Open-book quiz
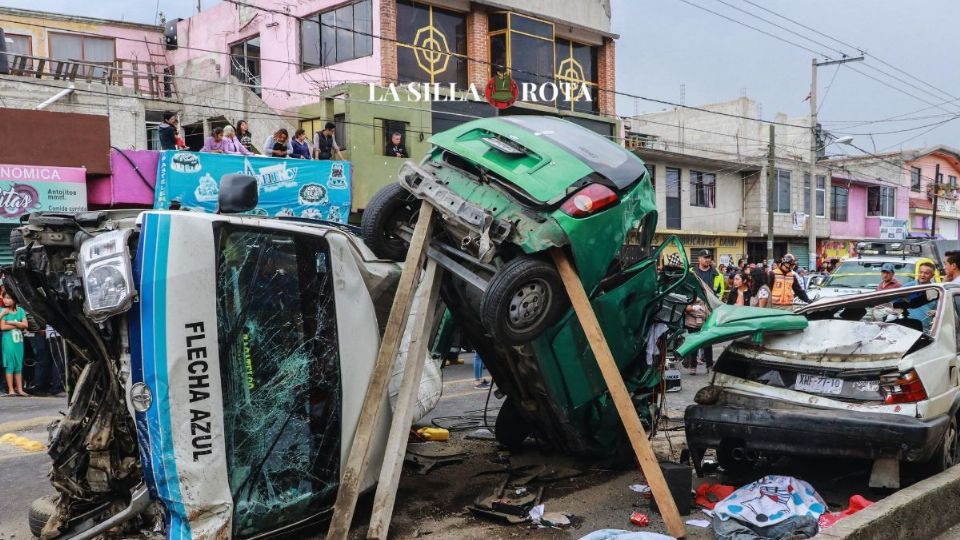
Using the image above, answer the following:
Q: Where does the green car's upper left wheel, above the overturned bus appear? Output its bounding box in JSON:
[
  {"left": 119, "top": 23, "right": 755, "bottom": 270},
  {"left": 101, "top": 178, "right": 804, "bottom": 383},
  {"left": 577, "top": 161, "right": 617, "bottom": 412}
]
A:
[{"left": 360, "top": 183, "right": 421, "bottom": 261}]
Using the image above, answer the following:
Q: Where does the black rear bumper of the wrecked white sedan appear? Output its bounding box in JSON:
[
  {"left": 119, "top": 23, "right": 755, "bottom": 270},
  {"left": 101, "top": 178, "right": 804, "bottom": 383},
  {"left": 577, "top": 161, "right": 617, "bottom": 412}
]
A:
[{"left": 684, "top": 396, "right": 949, "bottom": 461}]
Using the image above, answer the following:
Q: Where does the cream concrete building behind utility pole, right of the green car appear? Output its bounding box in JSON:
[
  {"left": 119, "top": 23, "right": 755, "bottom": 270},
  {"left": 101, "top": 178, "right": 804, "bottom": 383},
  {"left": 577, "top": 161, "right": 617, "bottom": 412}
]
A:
[{"left": 627, "top": 98, "right": 830, "bottom": 266}]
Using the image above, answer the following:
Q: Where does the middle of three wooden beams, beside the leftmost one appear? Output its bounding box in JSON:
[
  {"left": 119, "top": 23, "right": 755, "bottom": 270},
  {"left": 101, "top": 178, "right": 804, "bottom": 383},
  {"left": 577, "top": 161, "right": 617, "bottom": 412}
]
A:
[{"left": 367, "top": 259, "right": 441, "bottom": 540}]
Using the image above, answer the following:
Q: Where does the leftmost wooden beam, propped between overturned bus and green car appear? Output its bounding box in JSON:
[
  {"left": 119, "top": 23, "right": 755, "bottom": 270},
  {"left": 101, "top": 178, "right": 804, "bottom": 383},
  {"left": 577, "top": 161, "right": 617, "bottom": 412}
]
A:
[{"left": 327, "top": 204, "right": 433, "bottom": 540}]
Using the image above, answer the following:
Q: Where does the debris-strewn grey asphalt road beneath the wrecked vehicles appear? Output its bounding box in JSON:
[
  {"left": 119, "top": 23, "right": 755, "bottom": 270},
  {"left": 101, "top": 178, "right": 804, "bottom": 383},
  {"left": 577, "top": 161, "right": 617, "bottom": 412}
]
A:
[{"left": 0, "top": 348, "right": 950, "bottom": 540}]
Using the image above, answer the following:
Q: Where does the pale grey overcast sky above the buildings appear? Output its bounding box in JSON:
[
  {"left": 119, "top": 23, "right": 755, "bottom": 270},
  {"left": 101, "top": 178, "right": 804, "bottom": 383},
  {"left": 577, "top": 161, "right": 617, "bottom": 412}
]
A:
[{"left": 0, "top": 0, "right": 960, "bottom": 154}]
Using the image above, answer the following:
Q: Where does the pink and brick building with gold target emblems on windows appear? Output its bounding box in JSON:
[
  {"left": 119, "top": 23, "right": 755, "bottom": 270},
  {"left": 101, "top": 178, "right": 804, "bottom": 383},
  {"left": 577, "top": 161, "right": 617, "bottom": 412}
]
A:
[{"left": 167, "top": 0, "right": 619, "bottom": 210}]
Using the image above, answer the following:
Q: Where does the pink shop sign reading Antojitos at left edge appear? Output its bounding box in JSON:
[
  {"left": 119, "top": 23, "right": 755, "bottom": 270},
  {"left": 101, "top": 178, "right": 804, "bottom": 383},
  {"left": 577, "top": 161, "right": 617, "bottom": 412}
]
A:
[{"left": 0, "top": 165, "right": 87, "bottom": 223}]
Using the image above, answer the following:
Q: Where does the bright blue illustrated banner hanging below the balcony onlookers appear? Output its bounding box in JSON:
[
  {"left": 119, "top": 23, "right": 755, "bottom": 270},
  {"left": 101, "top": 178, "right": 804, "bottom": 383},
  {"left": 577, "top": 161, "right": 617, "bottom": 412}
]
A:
[{"left": 154, "top": 150, "right": 350, "bottom": 223}]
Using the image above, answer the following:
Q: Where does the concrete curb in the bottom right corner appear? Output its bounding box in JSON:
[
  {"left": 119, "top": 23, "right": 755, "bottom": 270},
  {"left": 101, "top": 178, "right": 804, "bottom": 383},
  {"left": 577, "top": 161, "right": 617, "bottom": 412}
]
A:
[{"left": 814, "top": 467, "right": 960, "bottom": 540}]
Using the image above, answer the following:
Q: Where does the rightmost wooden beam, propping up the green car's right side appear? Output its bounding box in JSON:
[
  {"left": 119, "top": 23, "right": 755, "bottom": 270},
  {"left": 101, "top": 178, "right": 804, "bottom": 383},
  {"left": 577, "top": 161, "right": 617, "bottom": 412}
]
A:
[{"left": 550, "top": 248, "right": 687, "bottom": 538}]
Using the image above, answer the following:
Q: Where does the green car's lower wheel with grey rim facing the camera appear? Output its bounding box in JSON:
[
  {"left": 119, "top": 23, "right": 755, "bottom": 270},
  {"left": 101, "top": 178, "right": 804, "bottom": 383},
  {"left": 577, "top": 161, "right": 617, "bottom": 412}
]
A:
[{"left": 480, "top": 256, "right": 569, "bottom": 345}]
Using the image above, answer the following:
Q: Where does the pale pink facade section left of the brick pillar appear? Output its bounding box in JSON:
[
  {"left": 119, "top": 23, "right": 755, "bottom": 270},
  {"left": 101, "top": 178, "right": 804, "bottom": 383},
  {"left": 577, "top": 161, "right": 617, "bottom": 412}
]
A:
[{"left": 168, "top": 0, "right": 381, "bottom": 110}]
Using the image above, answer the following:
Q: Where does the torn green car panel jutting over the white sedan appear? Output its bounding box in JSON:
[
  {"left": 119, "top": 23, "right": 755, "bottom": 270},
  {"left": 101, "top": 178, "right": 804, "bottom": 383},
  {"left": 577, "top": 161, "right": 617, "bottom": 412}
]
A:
[{"left": 677, "top": 304, "right": 809, "bottom": 356}]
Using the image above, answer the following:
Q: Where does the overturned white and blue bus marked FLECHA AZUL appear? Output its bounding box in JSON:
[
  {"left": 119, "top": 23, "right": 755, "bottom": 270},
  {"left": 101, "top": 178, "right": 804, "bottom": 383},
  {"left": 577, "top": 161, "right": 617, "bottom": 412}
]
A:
[{"left": 8, "top": 205, "right": 408, "bottom": 539}]
